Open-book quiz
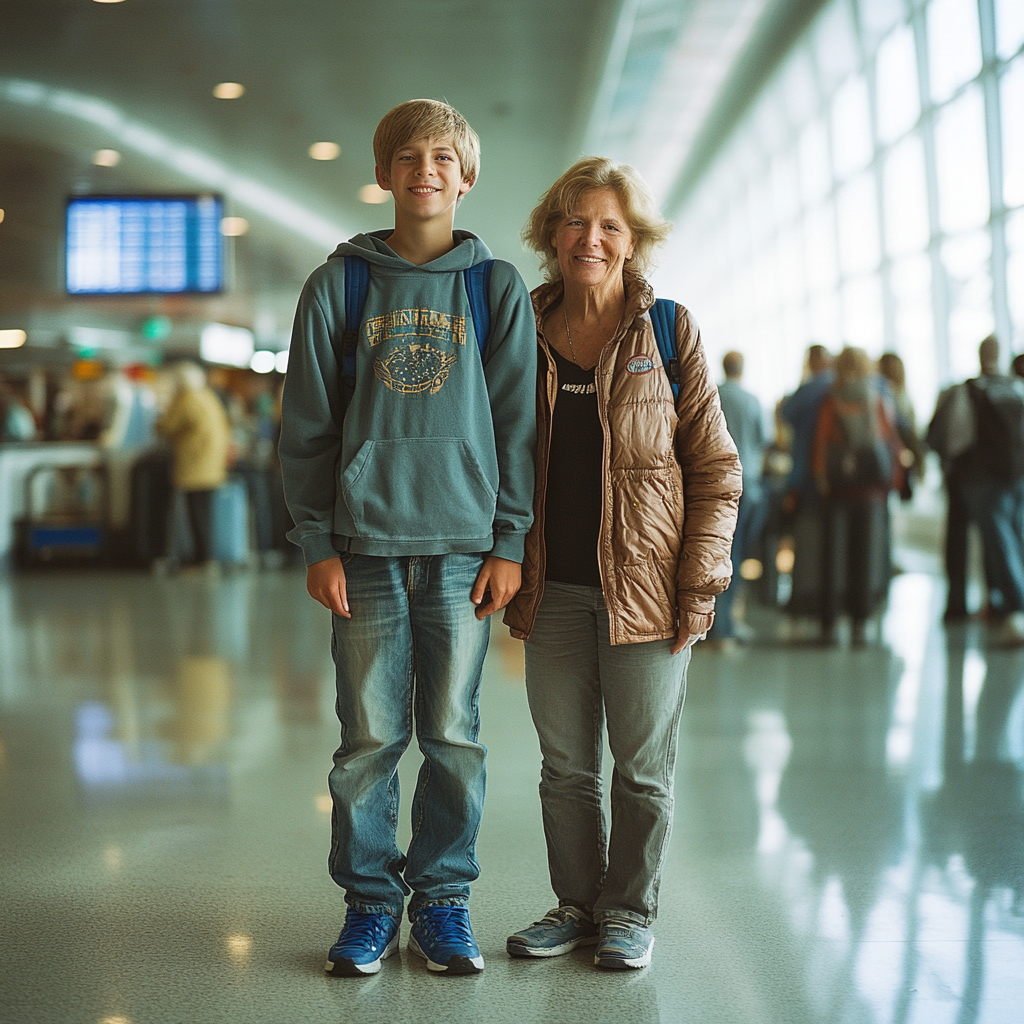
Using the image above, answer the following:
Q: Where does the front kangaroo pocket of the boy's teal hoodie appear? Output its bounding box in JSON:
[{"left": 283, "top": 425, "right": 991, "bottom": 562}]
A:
[{"left": 341, "top": 437, "right": 498, "bottom": 541}]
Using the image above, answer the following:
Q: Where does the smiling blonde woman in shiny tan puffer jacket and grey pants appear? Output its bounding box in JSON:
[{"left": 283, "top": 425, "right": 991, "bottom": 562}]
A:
[{"left": 505, "top": 158, "right": 740, "bottom": 968}]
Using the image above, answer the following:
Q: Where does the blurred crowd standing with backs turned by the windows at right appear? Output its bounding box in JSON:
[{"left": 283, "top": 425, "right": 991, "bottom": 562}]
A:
[{"left": 711, "top": 337, "right": 1024, "bottom": 646}]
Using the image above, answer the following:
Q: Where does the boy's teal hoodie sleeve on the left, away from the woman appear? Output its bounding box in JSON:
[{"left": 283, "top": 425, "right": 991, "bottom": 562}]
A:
[{"left": 279, "top": 272, "right": 344, "bottom": 566}]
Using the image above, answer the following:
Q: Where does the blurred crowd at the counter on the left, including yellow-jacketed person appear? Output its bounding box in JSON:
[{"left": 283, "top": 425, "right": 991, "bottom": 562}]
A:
[{"left": 0, "top": 360, "right": 290, "bottom": 567}]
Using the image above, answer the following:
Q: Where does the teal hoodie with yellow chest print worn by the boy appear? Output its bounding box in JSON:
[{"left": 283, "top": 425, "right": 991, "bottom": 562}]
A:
[{"left": 280, "top": 230, "right": 537, "bottom": 565}]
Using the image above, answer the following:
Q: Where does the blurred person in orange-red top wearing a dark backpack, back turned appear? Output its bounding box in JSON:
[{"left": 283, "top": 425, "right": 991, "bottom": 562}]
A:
[{"left": 811, "top": 347, "right": 902, "bottom": 646}]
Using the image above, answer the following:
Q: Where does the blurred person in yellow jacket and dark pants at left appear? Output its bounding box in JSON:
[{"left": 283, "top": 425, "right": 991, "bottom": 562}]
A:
[{"left": 157, "top": 362, "right": 231, "bottom": 565}]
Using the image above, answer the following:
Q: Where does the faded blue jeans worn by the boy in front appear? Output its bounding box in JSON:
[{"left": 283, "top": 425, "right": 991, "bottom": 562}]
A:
[{"left": 330, "top": 554, "right": 489, "bottom": 919}]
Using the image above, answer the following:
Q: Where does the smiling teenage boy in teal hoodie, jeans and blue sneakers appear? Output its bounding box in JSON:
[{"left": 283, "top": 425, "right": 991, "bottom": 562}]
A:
[{"left": 281, "top": 99, "right": 537, "bottom": 975}]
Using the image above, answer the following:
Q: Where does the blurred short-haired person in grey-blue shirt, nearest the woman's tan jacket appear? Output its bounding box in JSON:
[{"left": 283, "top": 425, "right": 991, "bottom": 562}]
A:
[{"left": 708, "top": 352, "right": 765, "bottom": 647}]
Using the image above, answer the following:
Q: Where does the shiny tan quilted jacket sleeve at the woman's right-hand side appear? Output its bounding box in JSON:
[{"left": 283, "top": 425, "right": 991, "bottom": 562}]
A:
[{"left": 676, "top": 304, "right": 742, "bottom": 634}]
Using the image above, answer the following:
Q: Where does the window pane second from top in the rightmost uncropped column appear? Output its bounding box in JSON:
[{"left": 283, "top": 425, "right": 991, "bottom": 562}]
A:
[{"left": 935, "top": 85, "right": 989, "bottom": 233}]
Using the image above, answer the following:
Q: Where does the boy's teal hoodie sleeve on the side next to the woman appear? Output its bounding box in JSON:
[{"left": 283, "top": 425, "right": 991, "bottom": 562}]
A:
[{"left": 483, "top": 260, "right": 537, "bottom": 562}]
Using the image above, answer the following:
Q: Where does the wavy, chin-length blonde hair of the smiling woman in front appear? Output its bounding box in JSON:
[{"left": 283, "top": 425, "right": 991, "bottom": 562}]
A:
[{"left": 522, "top": 157, "right": 672, "bottom": 281}]
